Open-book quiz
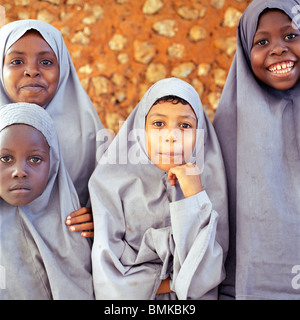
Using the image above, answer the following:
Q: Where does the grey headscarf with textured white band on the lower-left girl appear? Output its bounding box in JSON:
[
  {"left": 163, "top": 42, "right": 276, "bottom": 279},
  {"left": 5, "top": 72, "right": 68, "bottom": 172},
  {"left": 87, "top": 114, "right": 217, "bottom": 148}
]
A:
[{"left": 0, "top": 103, "right": 94, "bottom": 300}]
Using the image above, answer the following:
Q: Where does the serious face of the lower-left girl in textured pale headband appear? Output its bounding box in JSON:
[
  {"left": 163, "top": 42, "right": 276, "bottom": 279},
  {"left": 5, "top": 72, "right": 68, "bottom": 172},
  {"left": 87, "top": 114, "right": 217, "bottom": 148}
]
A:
[{"left": 0, "top": 124, "right": 50, "bottom": 206}]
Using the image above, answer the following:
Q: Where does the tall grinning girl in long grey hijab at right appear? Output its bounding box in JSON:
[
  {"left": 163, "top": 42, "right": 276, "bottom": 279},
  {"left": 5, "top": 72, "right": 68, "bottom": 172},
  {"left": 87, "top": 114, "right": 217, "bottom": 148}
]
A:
[{"left": 214, "top": 0, "right": 300, "bottom": 299}]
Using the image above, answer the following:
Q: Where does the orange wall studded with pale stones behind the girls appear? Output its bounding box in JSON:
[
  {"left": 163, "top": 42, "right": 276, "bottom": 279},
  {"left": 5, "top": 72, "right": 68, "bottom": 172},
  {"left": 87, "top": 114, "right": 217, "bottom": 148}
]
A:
[{"left": 0, "top": 0, "right": 251, "bottom": 132}]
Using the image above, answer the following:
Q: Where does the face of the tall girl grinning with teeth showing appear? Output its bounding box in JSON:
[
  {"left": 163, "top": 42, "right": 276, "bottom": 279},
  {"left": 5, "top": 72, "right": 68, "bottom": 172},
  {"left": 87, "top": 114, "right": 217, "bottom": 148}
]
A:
[{"left": 251, "top": 10, "right": 300, "bottom": 90}]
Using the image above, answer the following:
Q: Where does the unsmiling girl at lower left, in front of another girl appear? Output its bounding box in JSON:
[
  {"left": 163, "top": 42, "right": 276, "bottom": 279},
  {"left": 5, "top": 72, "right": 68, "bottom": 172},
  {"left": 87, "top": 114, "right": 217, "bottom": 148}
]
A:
[{"left": 0, "top": 103, "right": 94, "bottom": 300}]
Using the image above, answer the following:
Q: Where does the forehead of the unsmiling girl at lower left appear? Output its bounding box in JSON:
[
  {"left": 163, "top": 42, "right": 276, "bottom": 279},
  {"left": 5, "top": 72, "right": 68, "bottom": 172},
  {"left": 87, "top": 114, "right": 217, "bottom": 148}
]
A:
[{"left": 0, "top": 124, "right": 49, "bottom": 150}]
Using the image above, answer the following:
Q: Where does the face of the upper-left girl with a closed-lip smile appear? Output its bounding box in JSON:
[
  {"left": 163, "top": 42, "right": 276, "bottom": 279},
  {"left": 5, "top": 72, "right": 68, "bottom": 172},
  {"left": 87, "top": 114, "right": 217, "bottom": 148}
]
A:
[{"left": 3, "top": 31, "right": 59, "bottom": 106}]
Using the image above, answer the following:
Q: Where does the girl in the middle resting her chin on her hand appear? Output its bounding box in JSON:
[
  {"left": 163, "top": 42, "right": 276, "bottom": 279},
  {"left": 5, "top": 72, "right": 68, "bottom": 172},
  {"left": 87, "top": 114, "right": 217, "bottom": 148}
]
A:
[{"left": 89, "top": 78, "right": 228, "bottom": 299}]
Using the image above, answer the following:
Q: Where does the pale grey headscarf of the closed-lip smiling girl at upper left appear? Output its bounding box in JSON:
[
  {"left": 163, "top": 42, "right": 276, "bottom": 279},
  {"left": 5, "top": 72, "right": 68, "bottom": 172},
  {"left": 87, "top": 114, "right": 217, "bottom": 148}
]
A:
[{"left": 0, "top": 20, "right": 103, "bottom": 205}]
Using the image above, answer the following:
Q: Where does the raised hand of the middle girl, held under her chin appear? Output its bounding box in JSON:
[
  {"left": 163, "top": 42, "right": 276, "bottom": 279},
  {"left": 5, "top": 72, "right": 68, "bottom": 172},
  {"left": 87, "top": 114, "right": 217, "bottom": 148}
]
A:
[{"left": 168, "top": 163, "right": 203, "bottom": 198}]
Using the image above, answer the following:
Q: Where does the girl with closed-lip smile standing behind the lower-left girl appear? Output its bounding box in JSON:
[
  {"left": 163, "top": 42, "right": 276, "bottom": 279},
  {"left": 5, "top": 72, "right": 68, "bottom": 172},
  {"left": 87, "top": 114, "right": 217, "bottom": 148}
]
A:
[{"left": 0, "top": 20, "right": 104, "bottom": 225}]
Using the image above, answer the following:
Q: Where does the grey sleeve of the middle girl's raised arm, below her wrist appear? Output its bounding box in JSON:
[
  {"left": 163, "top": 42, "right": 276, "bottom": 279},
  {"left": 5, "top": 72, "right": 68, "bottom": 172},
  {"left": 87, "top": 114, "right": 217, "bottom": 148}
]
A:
[{"left": 170, "top": 191, "right": 225, "bottom": 299}]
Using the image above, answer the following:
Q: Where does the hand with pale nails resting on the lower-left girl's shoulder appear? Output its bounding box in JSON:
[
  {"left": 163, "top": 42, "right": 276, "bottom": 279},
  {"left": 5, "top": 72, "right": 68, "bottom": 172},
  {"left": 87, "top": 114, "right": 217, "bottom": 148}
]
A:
[{"left": 66, "top": 207, "right": 94, "bottom": 238}]
